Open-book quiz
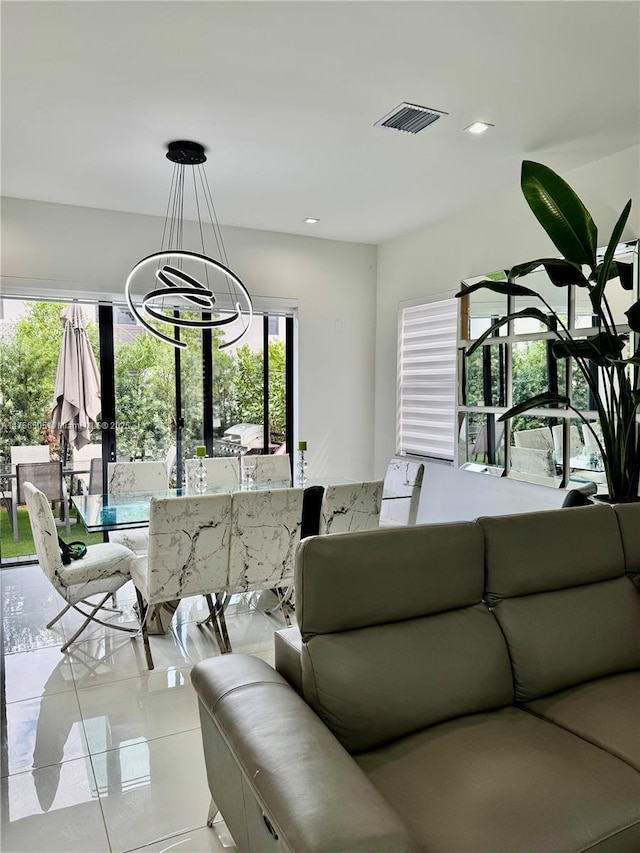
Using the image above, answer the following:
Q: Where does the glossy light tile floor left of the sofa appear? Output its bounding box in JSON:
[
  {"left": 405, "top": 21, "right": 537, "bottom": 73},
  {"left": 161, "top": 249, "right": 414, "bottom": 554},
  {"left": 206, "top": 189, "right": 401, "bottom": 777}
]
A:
[{"left": 0, "top": 566, "right": 284, "bottom": 853}]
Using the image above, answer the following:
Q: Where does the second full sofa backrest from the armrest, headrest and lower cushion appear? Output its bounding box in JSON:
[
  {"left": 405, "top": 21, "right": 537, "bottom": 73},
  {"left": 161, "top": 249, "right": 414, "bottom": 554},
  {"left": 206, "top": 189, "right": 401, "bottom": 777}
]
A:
[{"left": 478, "top": 506, "right": 640, "bottom": 702}]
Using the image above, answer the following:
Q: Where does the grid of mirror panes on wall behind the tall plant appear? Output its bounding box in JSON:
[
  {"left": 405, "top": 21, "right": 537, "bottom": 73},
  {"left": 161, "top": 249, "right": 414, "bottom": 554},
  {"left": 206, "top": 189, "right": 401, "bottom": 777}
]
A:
[{"left": 458, "top": 240, "right": 640, "bottom": 491}]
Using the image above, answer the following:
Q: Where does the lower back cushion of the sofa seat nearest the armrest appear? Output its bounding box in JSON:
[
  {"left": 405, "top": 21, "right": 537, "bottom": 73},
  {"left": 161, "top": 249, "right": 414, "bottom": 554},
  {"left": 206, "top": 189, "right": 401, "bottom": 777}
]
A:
[{"left": 302, "top": 600, "right": 513, "bottom": 753}]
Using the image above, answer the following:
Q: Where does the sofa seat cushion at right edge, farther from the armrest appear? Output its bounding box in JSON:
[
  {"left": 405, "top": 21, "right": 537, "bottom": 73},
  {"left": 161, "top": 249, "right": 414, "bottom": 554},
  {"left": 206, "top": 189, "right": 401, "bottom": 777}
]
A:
[{"left": 525, "top": 672, "right": 640, "bottom": 770}]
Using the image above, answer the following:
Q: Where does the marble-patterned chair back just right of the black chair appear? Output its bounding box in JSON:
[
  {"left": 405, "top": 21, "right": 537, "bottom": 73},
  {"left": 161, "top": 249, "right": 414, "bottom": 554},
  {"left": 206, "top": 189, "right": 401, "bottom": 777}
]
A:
[{"left": 320, "top": 480, "right": 383, "bottom": 534}]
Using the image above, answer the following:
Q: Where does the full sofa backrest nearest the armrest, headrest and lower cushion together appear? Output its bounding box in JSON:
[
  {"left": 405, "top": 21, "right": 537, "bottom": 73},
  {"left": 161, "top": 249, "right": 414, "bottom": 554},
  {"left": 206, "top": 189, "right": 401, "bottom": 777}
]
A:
[{"left": 296, "top": 522, "right": 513, "bottom": 753}]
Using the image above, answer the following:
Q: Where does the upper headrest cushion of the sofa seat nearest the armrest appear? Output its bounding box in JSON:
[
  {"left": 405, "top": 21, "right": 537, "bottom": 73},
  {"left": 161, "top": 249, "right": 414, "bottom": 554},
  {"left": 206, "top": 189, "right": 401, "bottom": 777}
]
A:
[{"left": 296, "top": 522, "right": 484, "bottom": 640}]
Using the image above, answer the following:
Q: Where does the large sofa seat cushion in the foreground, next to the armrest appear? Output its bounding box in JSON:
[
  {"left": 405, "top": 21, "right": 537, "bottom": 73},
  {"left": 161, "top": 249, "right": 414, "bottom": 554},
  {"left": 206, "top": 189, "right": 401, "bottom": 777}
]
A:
[{"left": 355, "top": 708, "right": 640, "bottom": 853}]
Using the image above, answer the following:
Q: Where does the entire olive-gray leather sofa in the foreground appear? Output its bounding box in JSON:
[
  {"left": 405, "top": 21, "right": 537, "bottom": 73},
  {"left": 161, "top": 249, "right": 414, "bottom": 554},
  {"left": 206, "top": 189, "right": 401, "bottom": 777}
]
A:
[{"left": 192, "top": 505, "right": 640, "bottom": 853}]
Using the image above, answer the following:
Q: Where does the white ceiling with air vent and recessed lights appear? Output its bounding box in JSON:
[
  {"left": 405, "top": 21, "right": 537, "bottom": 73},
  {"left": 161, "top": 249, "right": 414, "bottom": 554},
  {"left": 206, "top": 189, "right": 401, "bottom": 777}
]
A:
[{"left": 2, "top": 0, "right": 640, "bottom": 243}]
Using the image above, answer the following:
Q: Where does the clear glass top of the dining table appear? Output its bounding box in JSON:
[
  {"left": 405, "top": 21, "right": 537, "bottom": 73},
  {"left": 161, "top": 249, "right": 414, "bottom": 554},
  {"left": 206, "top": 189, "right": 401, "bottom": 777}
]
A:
[{"left": 71, "top": 477, "right": 402, "bottom": 533}]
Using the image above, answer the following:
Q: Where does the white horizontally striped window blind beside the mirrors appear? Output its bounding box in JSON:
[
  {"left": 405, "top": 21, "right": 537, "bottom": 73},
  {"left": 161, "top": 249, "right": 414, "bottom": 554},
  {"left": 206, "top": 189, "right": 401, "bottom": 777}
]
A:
[{"left": 398, "top": 298, "right": 458, "bottom": 459}]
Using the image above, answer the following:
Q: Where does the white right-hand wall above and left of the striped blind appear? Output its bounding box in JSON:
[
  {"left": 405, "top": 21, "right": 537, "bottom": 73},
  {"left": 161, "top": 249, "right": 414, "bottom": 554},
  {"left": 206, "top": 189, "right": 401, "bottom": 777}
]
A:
[{"left": 374, "top": 141, "right": 640, "bottom": 475}]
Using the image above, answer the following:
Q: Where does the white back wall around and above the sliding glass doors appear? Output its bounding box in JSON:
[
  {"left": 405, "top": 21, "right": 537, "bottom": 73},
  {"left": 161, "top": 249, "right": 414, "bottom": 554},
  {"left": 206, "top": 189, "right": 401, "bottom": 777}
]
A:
[{"left": 2, "top": 198, "right": 376, "bottom": 478}]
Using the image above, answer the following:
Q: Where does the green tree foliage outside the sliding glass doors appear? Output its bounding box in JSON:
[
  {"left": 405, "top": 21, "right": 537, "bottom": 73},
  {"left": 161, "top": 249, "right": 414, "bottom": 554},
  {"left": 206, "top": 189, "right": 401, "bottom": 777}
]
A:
[{"left": 0, "top": 302, "right": 285, "bottom": 460}]
